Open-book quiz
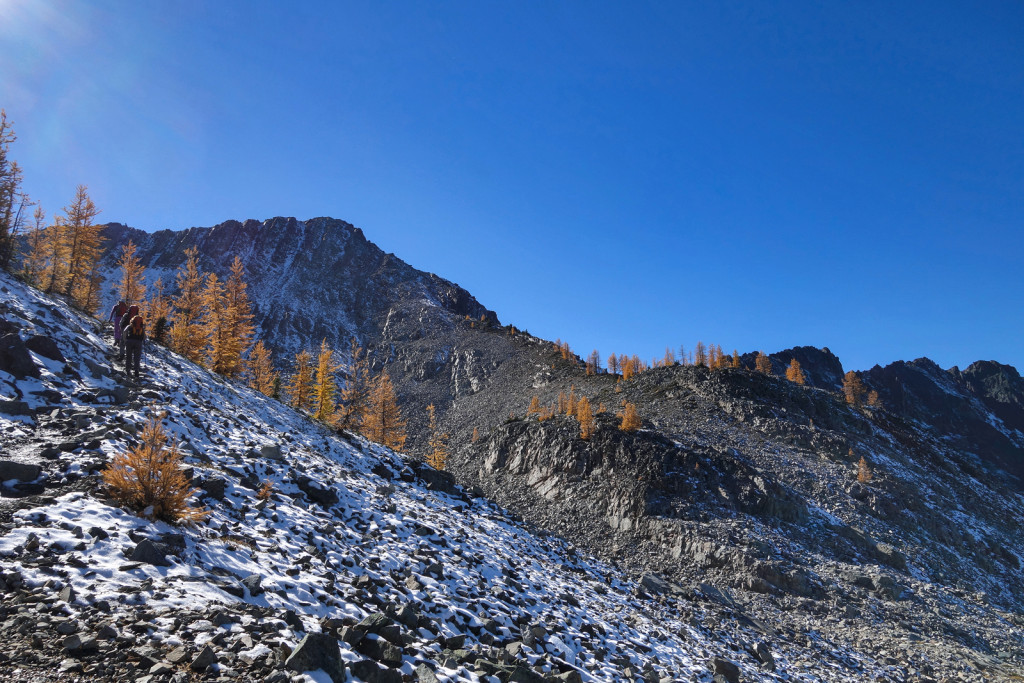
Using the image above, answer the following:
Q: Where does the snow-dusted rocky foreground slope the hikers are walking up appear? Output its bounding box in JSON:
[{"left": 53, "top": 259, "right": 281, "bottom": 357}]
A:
[{"left": 0, "top": 275, "right": 901, "bottom": 681}]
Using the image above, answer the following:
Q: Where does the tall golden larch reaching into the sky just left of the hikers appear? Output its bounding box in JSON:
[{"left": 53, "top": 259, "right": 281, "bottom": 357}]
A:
[{"left": 63, "top": 185, "right": 103, "bottom": 309}]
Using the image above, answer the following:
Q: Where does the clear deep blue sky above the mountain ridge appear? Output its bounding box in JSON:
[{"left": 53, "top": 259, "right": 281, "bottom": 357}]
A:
[{"left": 0, "top": 0, "right": 1024, "bottom": 370}]
